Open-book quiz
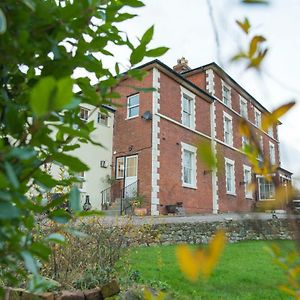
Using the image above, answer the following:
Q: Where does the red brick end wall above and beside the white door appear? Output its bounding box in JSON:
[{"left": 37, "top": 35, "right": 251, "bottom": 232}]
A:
[{"left": 113, "top": 71, "right": 152, "bottom": 208}]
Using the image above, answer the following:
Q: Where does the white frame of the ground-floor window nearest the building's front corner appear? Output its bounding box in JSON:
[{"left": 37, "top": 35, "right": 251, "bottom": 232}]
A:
[{"left": 181, "top": 142, "right": 197, "bottom": 189}]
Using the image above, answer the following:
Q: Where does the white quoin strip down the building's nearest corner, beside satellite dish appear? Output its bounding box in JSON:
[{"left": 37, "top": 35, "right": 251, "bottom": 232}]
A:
[{"left": 151, "top": 68, "right": 160, "bottom": 216}]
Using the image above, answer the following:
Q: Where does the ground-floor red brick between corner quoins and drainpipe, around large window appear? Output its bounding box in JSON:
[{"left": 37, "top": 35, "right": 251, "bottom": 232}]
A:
[{"left": 159, "top": 119, "right": 212, "bottom": 213}]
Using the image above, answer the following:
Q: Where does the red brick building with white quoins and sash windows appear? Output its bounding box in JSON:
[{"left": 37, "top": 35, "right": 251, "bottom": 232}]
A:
[{"left": 109, "top": 58, "right": 291, "bottom": 215}]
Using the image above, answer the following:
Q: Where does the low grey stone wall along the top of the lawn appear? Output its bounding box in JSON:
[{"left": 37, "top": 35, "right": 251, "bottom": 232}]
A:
[{"left": 151, "top": 219, "right": 293, "bottom": 244}]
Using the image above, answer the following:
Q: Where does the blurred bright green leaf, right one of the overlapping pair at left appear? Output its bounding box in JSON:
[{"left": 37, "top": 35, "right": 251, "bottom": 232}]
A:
[{"left": 52, "top": 77, "right": 73, "bottom": 110}]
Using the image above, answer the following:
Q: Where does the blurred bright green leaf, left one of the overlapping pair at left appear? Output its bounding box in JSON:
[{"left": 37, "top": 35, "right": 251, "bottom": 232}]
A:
[{"left": 30, "top": 76, "right": 56, "bottom": 117}]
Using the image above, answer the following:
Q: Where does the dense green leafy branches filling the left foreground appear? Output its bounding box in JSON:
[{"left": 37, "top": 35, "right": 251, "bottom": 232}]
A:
[{"left": 0, "top": 0, "right": 167, "bottom": 289}]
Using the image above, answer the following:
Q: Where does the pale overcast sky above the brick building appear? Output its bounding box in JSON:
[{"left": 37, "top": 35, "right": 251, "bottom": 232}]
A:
[{"left": 99, "top": 0, "right": 300, "bottom": 186}]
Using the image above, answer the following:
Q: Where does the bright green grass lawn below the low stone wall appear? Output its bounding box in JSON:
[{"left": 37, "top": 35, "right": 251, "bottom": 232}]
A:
[{"left": 125, "top": 241, "right": 293, "bottom": 300}]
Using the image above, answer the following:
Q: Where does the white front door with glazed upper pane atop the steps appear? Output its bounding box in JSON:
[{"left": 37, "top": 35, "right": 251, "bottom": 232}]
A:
[{"left": 124, "top": 155, "right": 138, "bottom": 198}]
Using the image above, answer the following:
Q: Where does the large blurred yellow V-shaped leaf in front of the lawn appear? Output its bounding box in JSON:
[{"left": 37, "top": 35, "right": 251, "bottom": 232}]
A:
[{"left": 176, "top": 230, "right": 226, "bottom": 282}]
